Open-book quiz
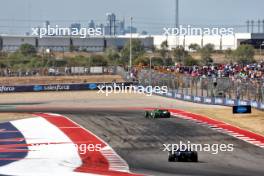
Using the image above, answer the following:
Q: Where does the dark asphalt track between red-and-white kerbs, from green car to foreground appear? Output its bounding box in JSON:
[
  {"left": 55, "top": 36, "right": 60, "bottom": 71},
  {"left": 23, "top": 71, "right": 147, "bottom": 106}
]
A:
[{"left": 63, "top": 110, "right": 264, "bottom": 176}]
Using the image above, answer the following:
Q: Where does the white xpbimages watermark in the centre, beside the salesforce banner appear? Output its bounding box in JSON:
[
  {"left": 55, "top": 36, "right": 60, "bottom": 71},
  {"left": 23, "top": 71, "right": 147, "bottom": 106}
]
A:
[{"left": 97, "top": 83, "right": 168, "bottom": 96}]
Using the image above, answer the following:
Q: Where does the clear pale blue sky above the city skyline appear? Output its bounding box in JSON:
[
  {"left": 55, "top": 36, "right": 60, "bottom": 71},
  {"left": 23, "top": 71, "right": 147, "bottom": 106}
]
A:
[{"left": 0, "top": 0, "right": 264, "bottom": 33}]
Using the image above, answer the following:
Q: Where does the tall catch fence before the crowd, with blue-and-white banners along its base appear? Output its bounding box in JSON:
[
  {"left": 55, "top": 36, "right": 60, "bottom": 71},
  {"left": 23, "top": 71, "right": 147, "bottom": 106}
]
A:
[{"left": 138, "top": 70, "right": 264, "bottom": 109}]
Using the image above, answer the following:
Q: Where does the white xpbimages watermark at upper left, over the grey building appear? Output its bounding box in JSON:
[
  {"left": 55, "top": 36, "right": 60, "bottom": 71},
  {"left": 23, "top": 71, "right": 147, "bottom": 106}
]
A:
[{"left": 31, "top": 25, "right": 104, "bottom": 38}]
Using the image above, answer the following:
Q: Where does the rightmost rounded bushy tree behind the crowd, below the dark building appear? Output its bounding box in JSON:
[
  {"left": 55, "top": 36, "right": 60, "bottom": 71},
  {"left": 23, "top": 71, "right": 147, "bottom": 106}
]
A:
[{"left": 234, "top": 45, "right": 255, "bottom": 64}]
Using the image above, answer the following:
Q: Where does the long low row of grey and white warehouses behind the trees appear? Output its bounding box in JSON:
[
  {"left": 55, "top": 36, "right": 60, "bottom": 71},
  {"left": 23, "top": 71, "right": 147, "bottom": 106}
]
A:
[{"left": 0, "top": 33, "right": 264, "bottom": 52}]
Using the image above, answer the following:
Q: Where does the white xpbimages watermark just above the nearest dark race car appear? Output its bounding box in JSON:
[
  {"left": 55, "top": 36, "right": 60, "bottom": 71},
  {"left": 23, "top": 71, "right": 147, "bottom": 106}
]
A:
[{"left": 163, "top": 141, "right": 234, "bottom": 155}]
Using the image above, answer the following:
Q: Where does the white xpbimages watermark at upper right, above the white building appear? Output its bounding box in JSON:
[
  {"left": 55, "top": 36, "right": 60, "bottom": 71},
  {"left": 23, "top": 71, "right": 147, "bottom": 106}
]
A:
[{"left": 163, "top": 25, "right": 234, "bottom": 36}]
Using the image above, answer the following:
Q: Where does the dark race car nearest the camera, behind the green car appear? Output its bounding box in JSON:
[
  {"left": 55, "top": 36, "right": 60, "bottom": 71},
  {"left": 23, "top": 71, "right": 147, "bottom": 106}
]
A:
[{"left": 168, "top": 149, "right": 198, "bottom": 162}]
